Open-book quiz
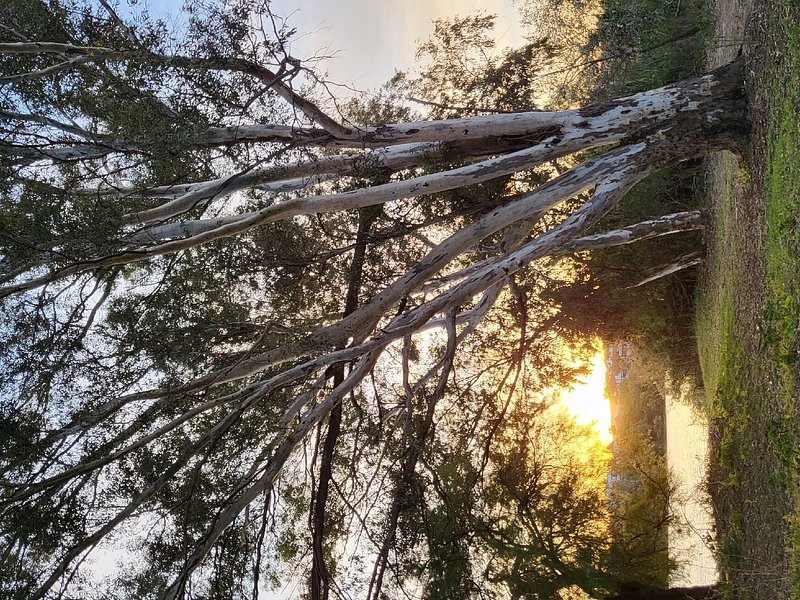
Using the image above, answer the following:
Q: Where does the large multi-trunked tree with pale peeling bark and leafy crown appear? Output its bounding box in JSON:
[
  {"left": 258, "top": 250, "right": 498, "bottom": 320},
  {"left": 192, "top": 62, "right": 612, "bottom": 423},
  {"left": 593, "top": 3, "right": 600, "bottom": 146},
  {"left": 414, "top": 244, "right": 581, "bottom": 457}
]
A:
[{"left": 0, "top": 0, "right": 747, "bottom": 599}]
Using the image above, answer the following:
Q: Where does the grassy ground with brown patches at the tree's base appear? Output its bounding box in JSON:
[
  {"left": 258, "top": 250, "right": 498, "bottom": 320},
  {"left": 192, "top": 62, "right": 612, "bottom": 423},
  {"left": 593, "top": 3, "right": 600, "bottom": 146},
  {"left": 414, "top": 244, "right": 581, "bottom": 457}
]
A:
[{"left": 696, "top": 0, "right": 800, "bottom": 600}]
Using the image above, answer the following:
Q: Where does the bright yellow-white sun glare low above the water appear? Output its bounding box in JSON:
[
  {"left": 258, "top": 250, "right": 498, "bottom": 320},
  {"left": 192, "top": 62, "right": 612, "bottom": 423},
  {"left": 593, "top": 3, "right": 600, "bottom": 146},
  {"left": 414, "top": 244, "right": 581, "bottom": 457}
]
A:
[{"left": 559, "top": 352, "right": 613, "bottom": 445}]
